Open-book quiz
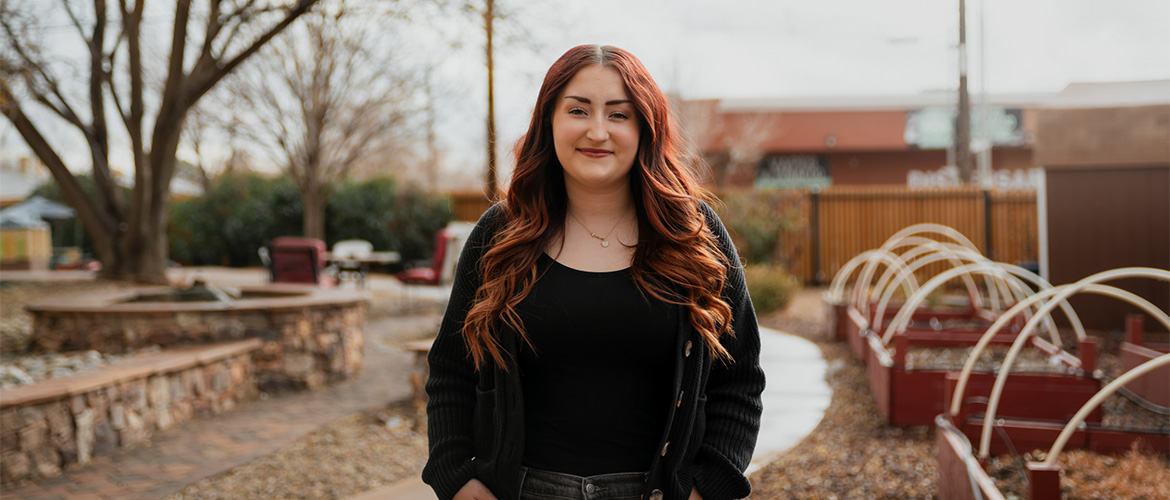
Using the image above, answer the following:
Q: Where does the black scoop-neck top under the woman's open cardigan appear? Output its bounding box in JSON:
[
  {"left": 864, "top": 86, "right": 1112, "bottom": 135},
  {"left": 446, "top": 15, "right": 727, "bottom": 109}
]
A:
[{"left": 517, "top": 255, "right": 677, "bottom": 475}]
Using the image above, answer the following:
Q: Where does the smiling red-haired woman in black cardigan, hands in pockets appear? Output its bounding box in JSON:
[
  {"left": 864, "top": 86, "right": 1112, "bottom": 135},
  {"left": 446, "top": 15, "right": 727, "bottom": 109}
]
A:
[{"left": 422, "top": 46, "right": 764, "bottom": 500}]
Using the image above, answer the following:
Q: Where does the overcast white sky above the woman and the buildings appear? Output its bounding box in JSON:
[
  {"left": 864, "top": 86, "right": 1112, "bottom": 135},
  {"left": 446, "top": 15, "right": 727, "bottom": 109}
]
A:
[{"left": 0, "top": 0, "right": 1170, "bottom": 187}]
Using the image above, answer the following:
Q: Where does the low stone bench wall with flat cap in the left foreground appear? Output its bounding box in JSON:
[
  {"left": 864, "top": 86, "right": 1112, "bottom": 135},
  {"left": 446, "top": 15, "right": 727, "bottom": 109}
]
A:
[{"left": 0, "top": 340, "right": 261, "bottom": 484}]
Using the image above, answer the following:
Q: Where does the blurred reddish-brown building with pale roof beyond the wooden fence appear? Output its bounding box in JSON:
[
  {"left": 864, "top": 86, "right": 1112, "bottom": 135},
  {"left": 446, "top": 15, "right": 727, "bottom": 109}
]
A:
[{"left": 680, "top": 81, "right": 1168, "bottom": 193}]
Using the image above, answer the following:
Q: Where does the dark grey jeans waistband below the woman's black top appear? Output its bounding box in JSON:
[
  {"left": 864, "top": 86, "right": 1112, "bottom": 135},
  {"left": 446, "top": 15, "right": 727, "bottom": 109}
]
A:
[{"left": 519, "top": 467, "right": 646, "bottom": 500}]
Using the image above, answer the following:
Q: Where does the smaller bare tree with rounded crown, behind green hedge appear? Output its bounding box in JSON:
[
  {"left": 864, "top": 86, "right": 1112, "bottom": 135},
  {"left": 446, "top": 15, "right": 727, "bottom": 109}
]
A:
[{"left": 224, "top": 1, "right": 412, "bottom": 239}]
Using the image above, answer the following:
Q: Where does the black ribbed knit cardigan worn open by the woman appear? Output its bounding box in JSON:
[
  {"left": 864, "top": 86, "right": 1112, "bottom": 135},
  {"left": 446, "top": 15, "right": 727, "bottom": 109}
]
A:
[{"left": 422, "top": 204, "right": 764, "bottom": 500}]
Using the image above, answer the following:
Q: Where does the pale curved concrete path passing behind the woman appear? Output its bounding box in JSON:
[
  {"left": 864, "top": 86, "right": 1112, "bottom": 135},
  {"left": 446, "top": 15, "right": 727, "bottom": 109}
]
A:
[{"left": 347, "top": 328, "right": 833, "bottom": 500}]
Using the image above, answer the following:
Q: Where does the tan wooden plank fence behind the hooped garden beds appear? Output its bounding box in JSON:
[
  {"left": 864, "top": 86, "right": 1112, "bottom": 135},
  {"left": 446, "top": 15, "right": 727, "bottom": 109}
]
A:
[{"left": 442, "top": 186, "right": 1039, "bottom": 283}]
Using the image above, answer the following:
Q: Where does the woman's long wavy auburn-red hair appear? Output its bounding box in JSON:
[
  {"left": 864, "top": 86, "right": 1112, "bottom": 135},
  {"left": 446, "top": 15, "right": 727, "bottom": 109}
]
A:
[{"left": 463, "top": 46, "right": 734, "bottom": 370}]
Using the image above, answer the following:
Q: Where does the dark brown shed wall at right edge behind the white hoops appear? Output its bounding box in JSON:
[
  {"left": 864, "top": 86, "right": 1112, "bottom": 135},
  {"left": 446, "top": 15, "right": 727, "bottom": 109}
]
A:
[{"left": 1046, "top": 164, "right": 1170, "bottom": 331}]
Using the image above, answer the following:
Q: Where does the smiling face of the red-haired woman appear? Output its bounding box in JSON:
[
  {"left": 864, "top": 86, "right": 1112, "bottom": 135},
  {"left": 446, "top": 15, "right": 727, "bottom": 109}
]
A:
[{"left": 552, "top": 64, "right": 641, "bottom": 191}]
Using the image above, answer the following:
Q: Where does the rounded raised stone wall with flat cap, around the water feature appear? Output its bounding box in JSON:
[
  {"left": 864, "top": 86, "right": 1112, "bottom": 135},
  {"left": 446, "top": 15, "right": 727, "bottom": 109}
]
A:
[{"left": 29, "top": 293, "right": 366, "bottom": 392}]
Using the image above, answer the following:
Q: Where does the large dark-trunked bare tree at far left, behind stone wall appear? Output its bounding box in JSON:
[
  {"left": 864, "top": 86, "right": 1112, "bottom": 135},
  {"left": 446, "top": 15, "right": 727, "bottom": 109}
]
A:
[{"left": 0, "top": 0, "right": 317, "bottom": 282}]
